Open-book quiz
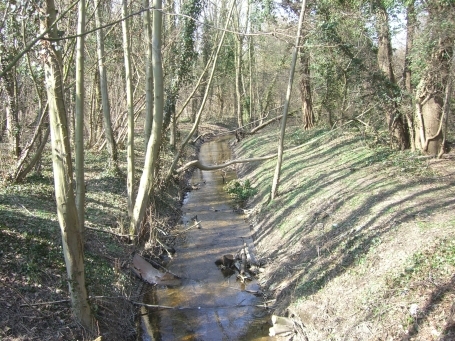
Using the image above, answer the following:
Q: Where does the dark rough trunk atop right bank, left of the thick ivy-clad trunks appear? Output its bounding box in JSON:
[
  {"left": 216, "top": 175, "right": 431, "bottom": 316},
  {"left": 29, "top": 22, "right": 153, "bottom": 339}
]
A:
[{"left": 376, "top": 0, "right": 409, "bottom": 149}]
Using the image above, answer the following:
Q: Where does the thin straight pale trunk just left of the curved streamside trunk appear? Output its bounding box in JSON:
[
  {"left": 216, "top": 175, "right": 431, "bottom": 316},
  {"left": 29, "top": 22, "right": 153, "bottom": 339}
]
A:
[{"left": 122, "top": 0, "right": 134, "bottom": 217}]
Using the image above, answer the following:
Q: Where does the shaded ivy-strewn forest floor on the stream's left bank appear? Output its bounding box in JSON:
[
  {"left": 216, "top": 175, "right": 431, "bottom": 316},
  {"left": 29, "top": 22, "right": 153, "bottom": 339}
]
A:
[{"left": 0, "top": 125, "right": 226, "bottom": 341}]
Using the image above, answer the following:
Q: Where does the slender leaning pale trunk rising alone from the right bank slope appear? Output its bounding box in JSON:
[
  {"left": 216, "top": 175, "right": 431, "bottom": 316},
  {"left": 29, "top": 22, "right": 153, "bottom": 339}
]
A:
[{"left": 271, "top": 0, "right": 306, "bottom": 200}]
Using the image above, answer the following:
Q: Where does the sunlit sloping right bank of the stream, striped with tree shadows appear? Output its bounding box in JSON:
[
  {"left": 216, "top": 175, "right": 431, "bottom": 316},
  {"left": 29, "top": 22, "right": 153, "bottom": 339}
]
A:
[{"left": 235, "top": 121, "right": 455, "bottom": 341}]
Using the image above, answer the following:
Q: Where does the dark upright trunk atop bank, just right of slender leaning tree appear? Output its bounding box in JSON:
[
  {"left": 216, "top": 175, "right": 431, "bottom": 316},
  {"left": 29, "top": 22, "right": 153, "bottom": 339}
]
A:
[{"left": 300, "top": 48, "right": 314, "bottom": 130}]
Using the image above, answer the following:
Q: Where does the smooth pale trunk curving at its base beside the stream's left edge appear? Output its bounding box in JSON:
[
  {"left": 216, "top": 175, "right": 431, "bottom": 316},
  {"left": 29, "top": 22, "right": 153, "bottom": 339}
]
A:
[{"left": 130, "top": 0, "right": 164, "bottom": 238}]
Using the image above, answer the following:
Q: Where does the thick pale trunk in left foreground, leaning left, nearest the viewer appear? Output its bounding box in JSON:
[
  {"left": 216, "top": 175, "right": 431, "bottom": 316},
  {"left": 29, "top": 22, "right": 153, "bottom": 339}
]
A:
[{"left": 40, "top": 0, "right": 93, "bottom": 330}]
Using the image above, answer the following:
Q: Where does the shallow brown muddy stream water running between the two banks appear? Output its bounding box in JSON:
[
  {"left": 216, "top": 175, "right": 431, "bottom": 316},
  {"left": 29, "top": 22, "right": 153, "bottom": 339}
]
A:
[{"left": 143, "top": 134, "right": 269, "bottom": 341}]
